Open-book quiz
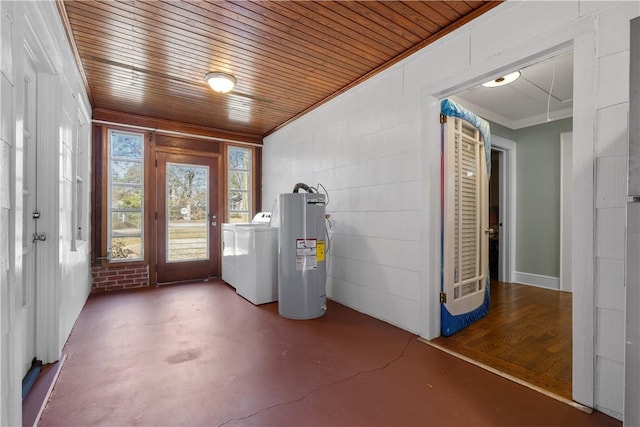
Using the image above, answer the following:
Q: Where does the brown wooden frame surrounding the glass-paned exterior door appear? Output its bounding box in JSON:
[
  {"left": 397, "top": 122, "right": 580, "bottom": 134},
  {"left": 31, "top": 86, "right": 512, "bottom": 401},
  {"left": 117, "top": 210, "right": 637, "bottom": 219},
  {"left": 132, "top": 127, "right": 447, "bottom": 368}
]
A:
[{"left": 153, "top": 146, "right": 226, "bottom": 284}]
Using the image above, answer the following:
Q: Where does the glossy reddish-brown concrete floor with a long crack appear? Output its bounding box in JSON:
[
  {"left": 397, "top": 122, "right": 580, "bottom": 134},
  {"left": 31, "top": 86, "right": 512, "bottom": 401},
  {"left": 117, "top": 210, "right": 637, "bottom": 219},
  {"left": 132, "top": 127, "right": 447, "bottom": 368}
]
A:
[{"left": 39, "top": 281, "right": 621, "bottom": 427}]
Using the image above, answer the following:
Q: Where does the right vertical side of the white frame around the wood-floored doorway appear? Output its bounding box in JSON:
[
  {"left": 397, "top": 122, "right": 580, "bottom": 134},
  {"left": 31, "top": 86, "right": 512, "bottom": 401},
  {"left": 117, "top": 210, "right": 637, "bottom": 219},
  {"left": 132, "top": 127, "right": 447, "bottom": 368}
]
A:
[{"left": 571, "top": 29, "right": 598, "bottom": 407}]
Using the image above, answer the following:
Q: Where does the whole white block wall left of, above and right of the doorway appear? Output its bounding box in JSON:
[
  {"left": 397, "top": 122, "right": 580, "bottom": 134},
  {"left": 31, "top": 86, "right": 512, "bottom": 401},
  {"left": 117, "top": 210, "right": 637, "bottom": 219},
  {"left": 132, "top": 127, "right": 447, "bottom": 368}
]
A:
[{"left": 263, "top": 1, "right": 640, "bottom": 419}]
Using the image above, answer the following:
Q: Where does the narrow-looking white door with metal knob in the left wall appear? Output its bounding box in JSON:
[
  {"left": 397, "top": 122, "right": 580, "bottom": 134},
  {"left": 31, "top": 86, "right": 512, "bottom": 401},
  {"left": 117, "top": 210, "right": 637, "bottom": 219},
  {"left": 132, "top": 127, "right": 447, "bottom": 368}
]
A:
[{"left": 20, "top": 60, "right": 39, "bottom": 377}]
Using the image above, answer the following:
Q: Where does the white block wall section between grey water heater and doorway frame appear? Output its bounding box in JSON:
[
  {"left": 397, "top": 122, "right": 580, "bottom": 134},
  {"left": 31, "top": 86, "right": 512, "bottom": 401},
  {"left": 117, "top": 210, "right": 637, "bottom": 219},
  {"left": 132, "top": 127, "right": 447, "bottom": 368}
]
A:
[{"left": 263, "top": 68, "right": 421, "bottom": 332}]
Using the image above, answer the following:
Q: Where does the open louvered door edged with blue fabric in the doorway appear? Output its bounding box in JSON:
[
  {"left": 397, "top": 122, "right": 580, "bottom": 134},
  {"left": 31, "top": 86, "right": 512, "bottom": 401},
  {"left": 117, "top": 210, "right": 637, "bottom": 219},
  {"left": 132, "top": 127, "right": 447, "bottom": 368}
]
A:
[{"left": 441, "top": 117, "right": 489, "bottom": 335}]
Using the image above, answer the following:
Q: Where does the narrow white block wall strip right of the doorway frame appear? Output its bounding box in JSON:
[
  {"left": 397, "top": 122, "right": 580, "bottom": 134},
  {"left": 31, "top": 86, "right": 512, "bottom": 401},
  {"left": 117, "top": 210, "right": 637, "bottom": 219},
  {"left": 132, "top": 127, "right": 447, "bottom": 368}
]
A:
[{"left": 594, "top": 2, "right": 640, "bottom": 418}]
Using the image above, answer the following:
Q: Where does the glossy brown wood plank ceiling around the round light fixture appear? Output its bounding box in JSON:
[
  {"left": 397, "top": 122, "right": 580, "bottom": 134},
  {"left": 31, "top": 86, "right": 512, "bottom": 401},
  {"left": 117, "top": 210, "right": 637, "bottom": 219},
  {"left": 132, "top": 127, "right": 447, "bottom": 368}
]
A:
[{"left": 58, "top": 0, "right": 500, "bottom": 137}]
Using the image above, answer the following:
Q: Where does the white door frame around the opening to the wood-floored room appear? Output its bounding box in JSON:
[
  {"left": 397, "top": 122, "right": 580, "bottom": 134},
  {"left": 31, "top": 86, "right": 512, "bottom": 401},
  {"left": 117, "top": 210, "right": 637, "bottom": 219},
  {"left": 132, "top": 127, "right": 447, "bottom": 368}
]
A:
[{"left": 419, "top": 17, "right": 598, "bottom": 407}]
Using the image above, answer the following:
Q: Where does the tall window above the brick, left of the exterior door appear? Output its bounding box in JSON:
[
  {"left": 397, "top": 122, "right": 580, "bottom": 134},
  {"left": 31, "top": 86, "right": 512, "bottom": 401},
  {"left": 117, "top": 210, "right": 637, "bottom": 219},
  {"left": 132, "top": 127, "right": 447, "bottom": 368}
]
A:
[{"left": 107, "top": 130, "right": 144, "bottom": 262}]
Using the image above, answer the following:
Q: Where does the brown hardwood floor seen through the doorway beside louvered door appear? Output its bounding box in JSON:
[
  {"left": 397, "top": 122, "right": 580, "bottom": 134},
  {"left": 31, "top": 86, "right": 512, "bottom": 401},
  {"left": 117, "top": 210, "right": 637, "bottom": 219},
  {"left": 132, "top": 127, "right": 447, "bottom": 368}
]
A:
[{"left": 432, "top": 281, "right": 572, "bottom": 400}]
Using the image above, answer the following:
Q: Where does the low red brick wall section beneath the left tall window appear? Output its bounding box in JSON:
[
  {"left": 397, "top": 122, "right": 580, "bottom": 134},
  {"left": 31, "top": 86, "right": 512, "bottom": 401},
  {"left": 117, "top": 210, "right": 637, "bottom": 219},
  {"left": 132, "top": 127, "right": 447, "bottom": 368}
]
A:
[{"left": 91, "top": 264, "right": 149, "bottom": 292}]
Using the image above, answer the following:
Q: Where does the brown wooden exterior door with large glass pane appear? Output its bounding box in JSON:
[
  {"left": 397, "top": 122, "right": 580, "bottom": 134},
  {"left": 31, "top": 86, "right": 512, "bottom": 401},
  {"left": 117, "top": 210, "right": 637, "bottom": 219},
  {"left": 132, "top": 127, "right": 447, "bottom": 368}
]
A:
[{"left": 156, "top": 152, "right": 220, "bottom": 283}]
